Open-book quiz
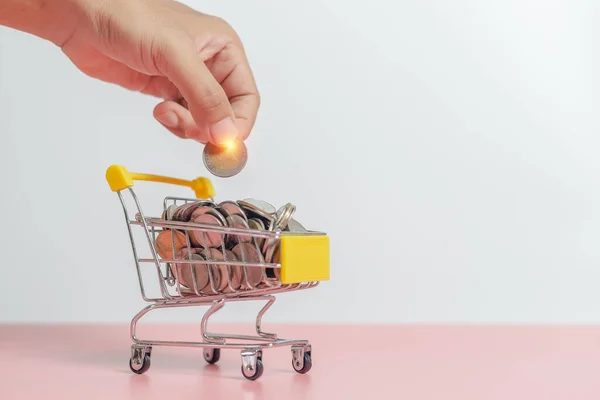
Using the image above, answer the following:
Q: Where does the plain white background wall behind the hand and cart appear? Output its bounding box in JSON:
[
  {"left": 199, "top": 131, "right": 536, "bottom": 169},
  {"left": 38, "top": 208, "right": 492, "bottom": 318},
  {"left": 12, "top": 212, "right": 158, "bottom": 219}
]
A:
[{"left": 0, "top": 0, "right": 600, "bottom": 323}]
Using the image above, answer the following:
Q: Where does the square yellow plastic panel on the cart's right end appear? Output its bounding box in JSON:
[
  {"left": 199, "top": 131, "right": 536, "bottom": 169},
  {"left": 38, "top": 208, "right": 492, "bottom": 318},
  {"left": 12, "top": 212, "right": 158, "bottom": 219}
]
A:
[{"left": 281, "top": 234, "right": 329, "bottom": 284}]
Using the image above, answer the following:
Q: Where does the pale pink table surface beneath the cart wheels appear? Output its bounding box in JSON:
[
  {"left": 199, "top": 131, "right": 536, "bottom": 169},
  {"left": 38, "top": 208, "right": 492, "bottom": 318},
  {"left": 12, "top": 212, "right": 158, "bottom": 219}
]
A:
[{"left": 0, "top": 325, "right": 600, "bottom": 400}]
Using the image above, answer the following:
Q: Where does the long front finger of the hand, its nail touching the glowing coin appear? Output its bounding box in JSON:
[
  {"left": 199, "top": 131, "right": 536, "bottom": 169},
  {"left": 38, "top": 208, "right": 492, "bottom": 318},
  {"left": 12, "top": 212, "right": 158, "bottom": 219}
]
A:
[{"left": 159, "top": 43, "right": 238, "bottom": 144}]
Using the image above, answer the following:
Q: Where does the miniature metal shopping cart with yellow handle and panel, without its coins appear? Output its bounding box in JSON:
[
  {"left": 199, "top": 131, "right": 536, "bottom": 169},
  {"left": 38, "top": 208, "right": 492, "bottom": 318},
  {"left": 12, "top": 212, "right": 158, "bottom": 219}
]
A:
[{"left": 106, "top": 165, "right": 329, "bottom": 380}]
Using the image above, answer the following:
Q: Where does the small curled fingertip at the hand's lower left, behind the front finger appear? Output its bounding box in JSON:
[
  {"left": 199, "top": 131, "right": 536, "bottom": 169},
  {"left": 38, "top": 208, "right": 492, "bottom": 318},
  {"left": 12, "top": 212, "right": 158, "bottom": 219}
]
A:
[{"left": 153, "top": 100, "right": 210, "bottom": 144}]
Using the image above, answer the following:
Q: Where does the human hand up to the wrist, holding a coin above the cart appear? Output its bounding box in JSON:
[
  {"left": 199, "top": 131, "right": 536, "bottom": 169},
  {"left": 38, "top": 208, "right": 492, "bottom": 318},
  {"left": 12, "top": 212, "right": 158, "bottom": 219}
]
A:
[{"left": 55, "top": 0, "right": 260, "bottom": 144}]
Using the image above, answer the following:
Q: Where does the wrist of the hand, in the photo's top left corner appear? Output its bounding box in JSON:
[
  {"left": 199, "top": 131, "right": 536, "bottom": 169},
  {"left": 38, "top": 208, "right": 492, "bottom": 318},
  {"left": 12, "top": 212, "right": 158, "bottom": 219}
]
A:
[{"left": 0, "top": 0, "right": 81, "bottom": 46}]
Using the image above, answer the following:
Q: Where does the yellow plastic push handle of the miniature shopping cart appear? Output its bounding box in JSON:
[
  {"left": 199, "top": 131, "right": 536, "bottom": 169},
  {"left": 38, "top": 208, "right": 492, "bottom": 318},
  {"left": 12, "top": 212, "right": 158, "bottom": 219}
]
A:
[{"left": 106, "top": 165, "right": 215, "bottom": 199}]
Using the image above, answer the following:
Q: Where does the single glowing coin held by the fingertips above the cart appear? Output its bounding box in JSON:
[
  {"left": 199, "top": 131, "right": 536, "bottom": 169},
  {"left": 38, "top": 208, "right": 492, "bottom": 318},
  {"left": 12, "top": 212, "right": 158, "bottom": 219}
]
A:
[{"left": 202, "top": 138, "right": 248, "bottom": 178}]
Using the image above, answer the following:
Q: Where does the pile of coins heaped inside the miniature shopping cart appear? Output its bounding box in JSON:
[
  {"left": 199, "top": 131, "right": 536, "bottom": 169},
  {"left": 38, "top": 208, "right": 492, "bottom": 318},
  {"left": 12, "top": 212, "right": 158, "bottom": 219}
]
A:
[{"left": 155, "top": 199, "right": 306, "bottom": 295}]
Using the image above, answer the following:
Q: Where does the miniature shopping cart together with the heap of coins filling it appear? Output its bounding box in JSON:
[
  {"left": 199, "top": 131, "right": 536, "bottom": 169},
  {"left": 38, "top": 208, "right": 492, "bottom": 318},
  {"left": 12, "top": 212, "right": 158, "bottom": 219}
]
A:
[{"left": 106, "top": 165, "right": 329, "bottom": 380}]
